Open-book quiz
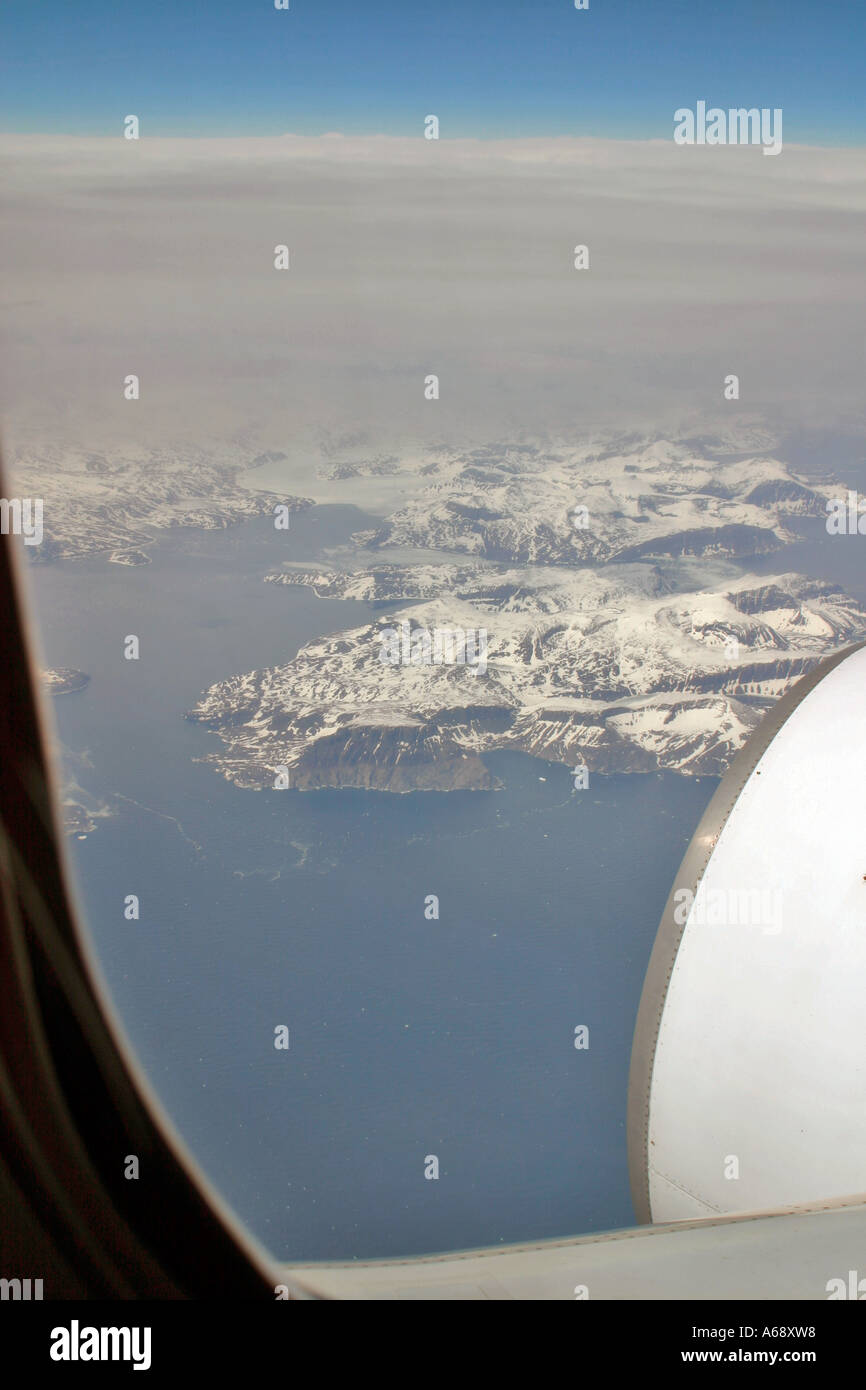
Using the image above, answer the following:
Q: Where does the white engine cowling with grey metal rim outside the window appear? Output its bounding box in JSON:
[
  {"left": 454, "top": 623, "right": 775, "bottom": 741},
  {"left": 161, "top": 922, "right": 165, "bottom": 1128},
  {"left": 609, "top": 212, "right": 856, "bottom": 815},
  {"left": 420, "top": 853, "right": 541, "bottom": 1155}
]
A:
[{"left": 628, "top": 645, "right": 866, "bottom": 1222}]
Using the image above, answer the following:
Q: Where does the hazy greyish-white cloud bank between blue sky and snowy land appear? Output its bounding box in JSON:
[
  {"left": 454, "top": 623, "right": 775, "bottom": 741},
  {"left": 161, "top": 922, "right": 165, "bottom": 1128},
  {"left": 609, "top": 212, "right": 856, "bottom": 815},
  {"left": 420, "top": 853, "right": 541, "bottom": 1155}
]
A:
[{"left": 0, "top": 134, "right": 866, "bottom": 472}]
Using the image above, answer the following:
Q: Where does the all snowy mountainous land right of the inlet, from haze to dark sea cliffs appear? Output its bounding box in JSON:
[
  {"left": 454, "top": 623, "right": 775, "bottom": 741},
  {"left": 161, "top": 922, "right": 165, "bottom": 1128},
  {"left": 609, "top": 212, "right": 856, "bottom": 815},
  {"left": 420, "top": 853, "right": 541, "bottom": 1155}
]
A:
[{"left": 189, "top": 441, "right": 866, "bottom": 791}]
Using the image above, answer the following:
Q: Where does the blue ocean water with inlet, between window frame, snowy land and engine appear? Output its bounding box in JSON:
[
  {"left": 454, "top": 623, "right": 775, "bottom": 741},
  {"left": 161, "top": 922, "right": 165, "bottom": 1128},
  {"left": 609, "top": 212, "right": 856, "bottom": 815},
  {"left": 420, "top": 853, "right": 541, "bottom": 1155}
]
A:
[{"left": 31, "top": 507, "right": 717, "bottom": 1259}]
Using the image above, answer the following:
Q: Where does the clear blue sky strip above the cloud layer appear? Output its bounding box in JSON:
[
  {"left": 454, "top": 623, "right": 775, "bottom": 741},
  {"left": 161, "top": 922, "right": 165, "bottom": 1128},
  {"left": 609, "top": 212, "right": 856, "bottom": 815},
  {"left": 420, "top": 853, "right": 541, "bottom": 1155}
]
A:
[{"left": 0, "top": 0, "right": 866, "bottom": 145}]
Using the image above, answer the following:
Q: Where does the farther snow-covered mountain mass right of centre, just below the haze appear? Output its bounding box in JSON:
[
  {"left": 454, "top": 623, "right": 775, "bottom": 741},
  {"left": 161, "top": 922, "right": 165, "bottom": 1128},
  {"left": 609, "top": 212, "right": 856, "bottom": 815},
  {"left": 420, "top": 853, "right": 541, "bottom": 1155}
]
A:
[{"left": 348, "top": 439, "right": 835, "bottom": 564}]
